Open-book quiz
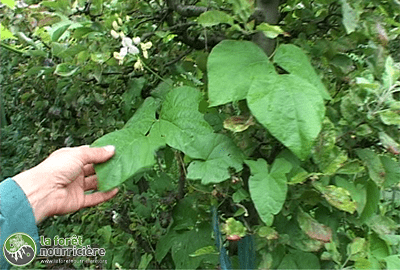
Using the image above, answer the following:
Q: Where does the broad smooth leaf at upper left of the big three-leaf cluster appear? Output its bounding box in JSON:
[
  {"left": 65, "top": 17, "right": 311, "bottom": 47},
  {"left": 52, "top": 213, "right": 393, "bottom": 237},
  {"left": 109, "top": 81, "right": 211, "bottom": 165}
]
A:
[{"left": 207, "top": 40, "right": 275, "bottom": 106}]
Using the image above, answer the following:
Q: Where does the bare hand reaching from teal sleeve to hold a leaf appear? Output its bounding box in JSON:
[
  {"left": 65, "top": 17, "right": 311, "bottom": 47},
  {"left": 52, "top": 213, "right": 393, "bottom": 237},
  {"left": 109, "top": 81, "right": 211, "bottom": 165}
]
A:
[{"left": 13, "top": 145, "right": 118, "bottom": 223}]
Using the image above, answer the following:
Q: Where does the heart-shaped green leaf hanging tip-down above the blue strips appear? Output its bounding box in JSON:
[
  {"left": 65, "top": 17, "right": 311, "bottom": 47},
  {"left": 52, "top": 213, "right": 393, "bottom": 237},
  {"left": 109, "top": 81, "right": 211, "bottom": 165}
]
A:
[{"left": 245, "top": 158, "right": 292, "bottom": 226}]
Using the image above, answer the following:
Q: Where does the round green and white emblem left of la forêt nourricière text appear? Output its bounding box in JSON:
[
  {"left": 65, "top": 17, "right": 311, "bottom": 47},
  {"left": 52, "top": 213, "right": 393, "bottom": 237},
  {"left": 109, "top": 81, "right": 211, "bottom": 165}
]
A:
[{"left": 3, "top": 233, "right": 36, "bottom": 266}]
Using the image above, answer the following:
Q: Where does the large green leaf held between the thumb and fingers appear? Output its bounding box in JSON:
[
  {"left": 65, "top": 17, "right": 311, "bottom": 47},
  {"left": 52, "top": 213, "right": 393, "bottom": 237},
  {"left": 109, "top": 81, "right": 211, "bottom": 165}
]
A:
[{"left": 92, "top": 98, "right": 165, "bottom": 191}]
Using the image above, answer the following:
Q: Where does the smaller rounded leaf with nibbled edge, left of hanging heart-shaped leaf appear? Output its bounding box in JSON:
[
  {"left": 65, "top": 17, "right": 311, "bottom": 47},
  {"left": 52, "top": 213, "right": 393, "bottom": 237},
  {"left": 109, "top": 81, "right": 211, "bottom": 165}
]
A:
[{"left": 187, "top": 133, "right": 244, "bottom": 185}]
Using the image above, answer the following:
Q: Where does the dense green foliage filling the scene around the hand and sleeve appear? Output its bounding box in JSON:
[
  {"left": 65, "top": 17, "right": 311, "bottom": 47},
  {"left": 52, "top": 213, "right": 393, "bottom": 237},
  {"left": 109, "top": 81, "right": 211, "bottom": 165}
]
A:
[{"left": 0, "top": 0, "right": 400, "bottom": 269}]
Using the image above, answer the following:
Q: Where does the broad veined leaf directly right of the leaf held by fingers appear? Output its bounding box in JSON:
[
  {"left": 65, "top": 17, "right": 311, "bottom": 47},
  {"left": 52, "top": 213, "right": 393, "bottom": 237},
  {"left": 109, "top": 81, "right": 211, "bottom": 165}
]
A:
[{"left": 153, "top": 87, "right": 216, "bottom": 155}]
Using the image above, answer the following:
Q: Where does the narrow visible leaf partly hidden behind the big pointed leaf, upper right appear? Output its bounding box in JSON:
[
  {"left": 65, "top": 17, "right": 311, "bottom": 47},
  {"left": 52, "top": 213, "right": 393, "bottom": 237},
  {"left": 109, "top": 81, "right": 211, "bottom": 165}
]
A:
[{"left": 274, "top": 44, "right": 331, "bottom": 99}]
